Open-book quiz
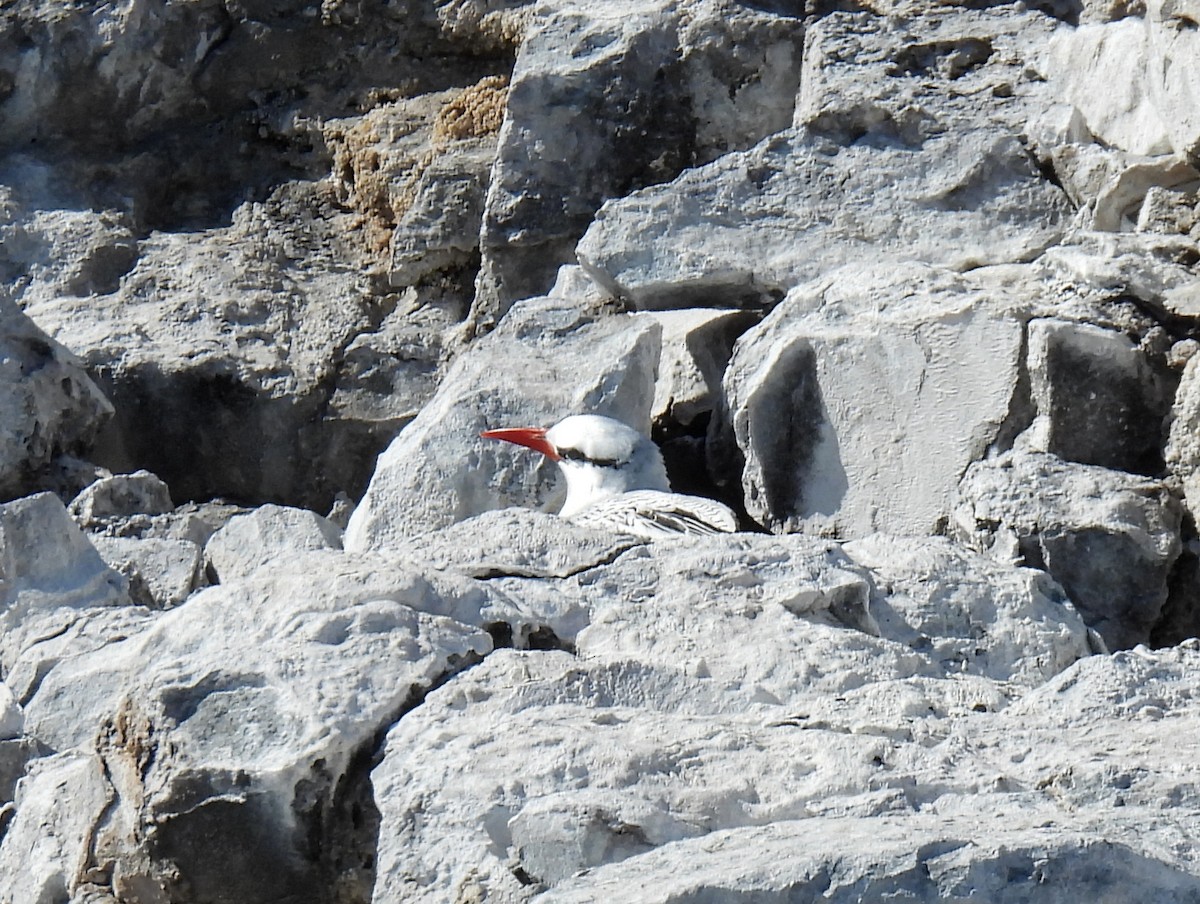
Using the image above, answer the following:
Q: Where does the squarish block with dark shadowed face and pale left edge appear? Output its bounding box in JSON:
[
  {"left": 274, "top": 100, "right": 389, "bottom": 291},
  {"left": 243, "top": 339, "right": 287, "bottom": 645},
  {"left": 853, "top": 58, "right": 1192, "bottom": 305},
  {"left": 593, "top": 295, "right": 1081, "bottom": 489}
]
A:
[{"left": 1027, "top": 319, "right": 1176, "bottom": 474}]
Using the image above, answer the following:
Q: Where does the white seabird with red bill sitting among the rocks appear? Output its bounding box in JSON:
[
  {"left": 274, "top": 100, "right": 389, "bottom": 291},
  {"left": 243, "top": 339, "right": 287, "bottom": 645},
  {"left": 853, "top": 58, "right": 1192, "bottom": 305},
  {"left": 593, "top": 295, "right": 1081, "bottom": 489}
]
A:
[{"left": 480, "top": 414, "right": 738, "bottom": 539}]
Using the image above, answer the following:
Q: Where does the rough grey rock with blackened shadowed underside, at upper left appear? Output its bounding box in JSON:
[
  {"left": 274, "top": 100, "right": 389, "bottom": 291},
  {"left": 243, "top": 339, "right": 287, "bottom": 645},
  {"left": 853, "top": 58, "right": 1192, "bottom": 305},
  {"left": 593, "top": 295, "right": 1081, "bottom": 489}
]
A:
[{"left": 29, "top": 186, "right": 384, "bottom": 508}]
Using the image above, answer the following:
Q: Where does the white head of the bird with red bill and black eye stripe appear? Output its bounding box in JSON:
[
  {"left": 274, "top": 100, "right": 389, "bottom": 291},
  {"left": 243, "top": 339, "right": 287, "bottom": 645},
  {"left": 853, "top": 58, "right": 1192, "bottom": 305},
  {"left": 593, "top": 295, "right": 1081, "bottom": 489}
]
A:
[{"left": 481, "top": 414, "right": 671, "bottom": 517}]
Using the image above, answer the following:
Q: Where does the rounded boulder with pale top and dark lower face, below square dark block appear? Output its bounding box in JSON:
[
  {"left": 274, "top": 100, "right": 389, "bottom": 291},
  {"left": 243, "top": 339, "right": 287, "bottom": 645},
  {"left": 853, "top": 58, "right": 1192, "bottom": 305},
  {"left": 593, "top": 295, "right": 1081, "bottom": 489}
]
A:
[{"left": 954, "top": 451, "right": 1181, "bottom": 649}]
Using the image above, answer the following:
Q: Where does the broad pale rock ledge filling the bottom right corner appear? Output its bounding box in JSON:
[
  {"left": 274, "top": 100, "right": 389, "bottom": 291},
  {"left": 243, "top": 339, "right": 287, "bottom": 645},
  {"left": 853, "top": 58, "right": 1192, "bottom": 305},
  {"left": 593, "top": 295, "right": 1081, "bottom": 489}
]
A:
[{"left": 372, "top": 635, "right": 1200, "bottom": 903}]
